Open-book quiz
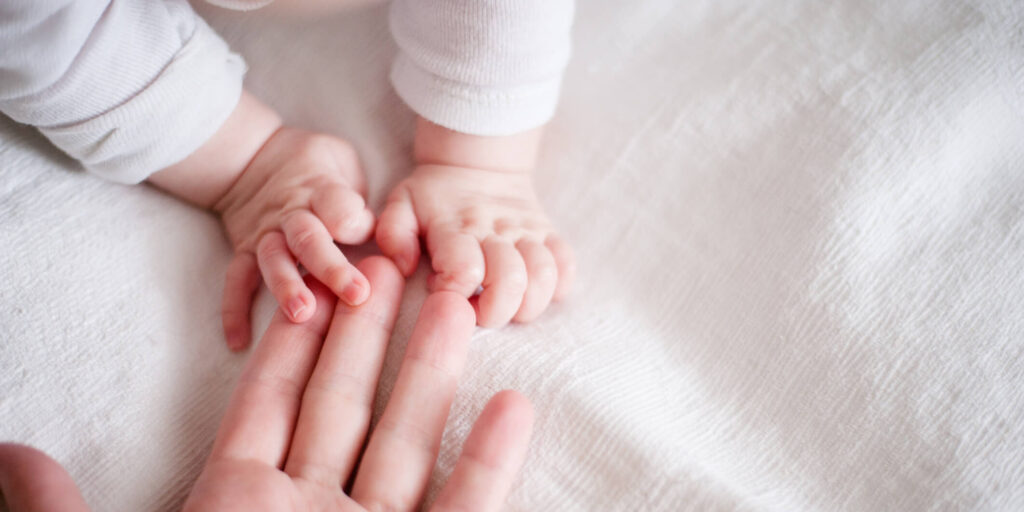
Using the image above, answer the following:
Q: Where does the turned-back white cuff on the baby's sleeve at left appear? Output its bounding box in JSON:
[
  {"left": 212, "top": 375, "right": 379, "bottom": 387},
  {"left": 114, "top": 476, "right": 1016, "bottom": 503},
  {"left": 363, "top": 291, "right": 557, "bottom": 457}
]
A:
[{"left": 40, "top": 19, "right": 246, "bottom": 183}]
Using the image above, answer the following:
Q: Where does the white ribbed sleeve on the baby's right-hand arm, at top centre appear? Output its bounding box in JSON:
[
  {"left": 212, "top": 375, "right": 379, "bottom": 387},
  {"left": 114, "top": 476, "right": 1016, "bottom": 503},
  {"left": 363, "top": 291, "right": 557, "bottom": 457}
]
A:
[{"left": 390, "top": 0, "right": 573, "bottom": 135}]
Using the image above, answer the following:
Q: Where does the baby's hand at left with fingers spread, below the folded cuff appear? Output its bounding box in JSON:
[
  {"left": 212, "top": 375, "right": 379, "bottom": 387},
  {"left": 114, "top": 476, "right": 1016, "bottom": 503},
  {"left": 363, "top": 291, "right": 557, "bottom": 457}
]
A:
[{"left": 214, "top": 127, "right": 374, "bottom": 350}]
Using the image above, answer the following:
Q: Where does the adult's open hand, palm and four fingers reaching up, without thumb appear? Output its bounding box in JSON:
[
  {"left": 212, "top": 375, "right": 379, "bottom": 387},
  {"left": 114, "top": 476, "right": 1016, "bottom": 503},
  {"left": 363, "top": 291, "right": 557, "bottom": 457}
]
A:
[{"left": 185, "top": 257, "right": 532, "bottom": 511}]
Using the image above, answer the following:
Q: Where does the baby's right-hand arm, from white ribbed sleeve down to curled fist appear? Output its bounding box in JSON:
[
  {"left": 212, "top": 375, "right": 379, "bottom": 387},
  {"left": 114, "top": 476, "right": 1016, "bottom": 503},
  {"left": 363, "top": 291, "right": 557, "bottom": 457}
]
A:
[{"left": 377, "top": 0, "right": 573, "bottom": 327}]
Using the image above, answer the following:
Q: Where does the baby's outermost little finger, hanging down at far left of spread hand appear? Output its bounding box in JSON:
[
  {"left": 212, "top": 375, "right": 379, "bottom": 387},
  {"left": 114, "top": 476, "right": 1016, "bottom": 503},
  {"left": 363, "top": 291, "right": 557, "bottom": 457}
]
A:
[{"left": 220, "top": 252, "right": 260, "bottom": 350}]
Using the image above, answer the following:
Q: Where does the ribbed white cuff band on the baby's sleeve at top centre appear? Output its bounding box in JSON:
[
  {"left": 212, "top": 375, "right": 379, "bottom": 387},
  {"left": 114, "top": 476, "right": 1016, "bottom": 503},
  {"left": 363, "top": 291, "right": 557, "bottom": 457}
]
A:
[{"left": 391, "top": 52, "right": 561, "bottom": 136}]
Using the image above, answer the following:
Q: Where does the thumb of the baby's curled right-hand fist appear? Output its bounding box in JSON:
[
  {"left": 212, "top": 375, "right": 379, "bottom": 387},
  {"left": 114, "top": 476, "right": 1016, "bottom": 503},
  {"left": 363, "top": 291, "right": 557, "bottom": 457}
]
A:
[{"left": 377, "top": 185, "right": 420, "bottom": 276}]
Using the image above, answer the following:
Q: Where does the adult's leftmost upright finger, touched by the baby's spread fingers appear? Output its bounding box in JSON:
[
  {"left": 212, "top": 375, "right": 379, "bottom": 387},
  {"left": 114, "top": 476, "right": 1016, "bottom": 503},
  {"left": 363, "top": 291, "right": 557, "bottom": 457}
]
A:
[{"left": 210, "top": 280, "right": 335, "bottom": 467}]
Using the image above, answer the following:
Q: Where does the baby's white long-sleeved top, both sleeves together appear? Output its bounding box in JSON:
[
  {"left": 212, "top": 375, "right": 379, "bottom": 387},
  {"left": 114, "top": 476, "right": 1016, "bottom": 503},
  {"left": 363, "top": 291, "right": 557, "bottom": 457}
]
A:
[{"left": 0, "top": 0, "right": 572, "bottom": 183}]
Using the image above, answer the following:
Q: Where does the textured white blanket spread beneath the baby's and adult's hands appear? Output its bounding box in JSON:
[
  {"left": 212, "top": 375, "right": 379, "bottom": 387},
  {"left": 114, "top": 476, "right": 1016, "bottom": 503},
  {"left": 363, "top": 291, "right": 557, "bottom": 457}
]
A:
[{"left": 0, "top": 0, "right": 1024, "bottom": 512}]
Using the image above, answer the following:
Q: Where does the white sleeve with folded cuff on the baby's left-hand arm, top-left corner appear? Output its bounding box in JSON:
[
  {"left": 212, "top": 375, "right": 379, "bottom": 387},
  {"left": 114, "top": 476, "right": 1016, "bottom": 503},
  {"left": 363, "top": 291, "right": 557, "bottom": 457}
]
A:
[{"left": 0, "top": 0, "right": 245, "bottom": 183}]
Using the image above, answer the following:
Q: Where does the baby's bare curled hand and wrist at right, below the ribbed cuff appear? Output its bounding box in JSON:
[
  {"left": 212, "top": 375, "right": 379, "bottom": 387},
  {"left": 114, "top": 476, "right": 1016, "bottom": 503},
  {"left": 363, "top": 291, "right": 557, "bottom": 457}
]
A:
[{"left": 377, "top": 121, "right": 574, "bottom": 327}]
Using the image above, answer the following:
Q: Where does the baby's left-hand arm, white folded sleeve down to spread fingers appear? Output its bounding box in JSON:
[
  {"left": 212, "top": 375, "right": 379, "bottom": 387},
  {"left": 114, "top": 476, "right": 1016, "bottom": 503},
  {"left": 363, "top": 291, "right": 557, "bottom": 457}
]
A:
[{"left": 0, "top": 0, "right": 373, "bottom": 348}]
